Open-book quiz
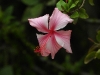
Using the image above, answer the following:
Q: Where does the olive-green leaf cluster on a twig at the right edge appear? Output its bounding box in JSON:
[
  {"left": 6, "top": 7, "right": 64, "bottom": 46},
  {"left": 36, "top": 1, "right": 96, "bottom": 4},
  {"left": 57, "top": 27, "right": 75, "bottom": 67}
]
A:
[{"left": 84, "top": 30, "right": 100, "bottom": 64}]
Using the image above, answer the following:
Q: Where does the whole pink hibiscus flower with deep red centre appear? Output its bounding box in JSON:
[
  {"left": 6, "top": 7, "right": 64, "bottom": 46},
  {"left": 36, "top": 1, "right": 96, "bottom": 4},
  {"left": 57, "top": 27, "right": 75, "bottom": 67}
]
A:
[{"left": 28, "top": 8, "right": 73, "bottom": 59}]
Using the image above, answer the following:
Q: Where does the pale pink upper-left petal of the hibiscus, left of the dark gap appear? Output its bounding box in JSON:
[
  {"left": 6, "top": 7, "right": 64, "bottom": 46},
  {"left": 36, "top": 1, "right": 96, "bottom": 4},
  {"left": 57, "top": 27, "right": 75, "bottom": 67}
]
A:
[{"left": 28, "top": 14, "right": 49, "bottom": 33}]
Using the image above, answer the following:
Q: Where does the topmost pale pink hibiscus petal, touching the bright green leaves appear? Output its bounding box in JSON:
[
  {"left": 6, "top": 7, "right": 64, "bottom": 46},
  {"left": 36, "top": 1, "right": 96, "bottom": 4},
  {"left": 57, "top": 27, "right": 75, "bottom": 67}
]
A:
[{"left": 49, "top": 8, "right": 73, "bottom": 30}]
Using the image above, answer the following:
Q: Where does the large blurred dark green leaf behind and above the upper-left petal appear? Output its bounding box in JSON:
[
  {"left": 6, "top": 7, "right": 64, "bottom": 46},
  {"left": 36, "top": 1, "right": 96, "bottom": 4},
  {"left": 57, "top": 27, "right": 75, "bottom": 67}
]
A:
[{"left": 22, "top": 4, "right": 44, "bottom": 21}]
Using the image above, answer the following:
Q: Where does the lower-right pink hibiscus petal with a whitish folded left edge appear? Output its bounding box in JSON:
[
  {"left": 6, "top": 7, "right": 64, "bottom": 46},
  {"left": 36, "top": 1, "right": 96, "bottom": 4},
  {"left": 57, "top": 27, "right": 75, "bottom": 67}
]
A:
[{"left": 55, "top": 30, "right": 72, "bottom": 53}]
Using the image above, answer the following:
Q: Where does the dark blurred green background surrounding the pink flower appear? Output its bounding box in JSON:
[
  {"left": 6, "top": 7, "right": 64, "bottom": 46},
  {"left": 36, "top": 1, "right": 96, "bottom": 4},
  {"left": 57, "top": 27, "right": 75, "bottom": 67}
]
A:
[{"left": 0, "top": 0, "right": 100, "bottom": 75}]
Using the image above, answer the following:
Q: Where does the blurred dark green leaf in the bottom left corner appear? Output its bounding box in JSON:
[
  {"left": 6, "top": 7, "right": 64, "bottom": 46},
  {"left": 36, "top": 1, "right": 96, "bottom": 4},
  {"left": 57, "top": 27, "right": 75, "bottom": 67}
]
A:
[{"left": 0, "top": 66, "right": 14, "bottom": 75}]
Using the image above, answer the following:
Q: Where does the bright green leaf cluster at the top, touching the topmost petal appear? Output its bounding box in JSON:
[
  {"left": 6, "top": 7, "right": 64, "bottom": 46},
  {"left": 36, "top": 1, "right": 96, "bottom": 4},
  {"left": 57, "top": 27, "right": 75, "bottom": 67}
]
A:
[{"left": 57, "top": 0, "right": 88, "bottom": 23}]
